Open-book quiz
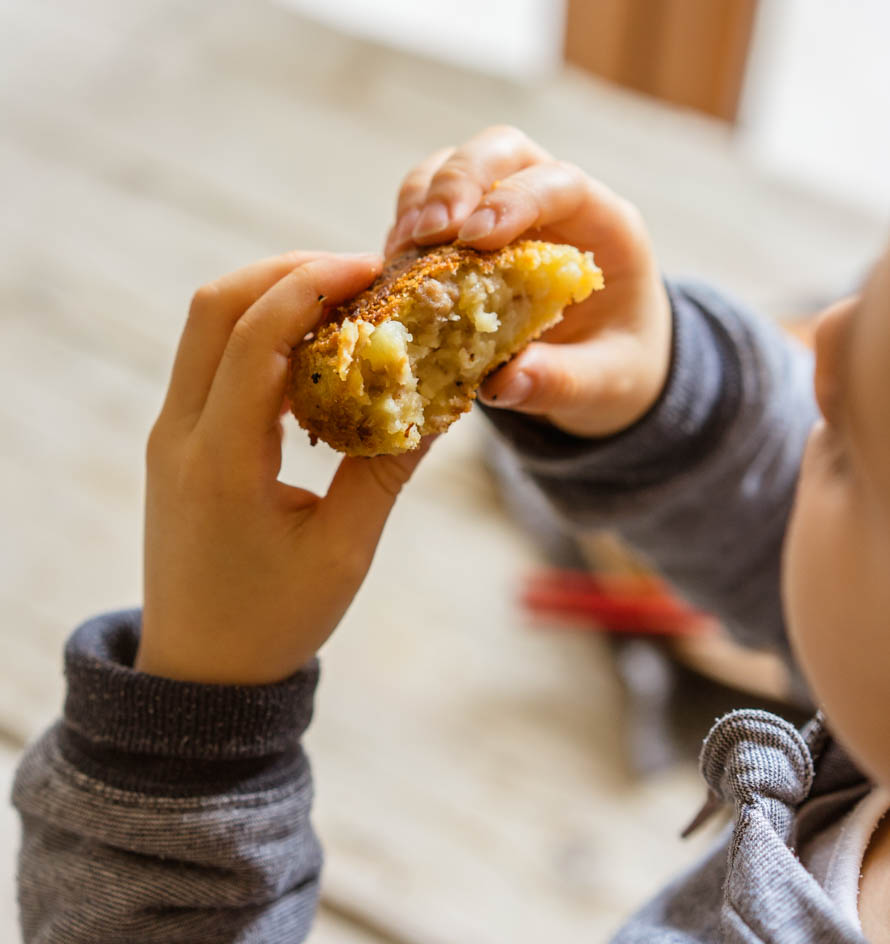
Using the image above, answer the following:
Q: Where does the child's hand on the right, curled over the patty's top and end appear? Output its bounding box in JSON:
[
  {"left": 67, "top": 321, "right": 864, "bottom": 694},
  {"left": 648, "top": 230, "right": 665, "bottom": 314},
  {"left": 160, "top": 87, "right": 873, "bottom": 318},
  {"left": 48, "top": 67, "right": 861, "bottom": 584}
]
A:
[{"left": 386, "top": 127, "right": 671, "bottom": 436}]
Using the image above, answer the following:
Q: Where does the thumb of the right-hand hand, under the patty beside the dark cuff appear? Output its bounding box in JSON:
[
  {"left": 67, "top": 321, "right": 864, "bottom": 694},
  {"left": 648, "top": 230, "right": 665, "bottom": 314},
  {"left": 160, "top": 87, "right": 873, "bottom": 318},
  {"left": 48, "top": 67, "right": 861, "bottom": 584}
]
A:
[{"left": 479, "top": 333, "right": 651, "bottom": 436}]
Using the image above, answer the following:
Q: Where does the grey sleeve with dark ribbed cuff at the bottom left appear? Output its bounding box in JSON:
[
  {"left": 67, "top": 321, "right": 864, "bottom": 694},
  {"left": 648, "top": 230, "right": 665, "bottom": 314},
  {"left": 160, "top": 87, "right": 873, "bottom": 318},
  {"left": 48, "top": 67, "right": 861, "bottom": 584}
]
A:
[{"left": 13, "top": 611, "right": 321, "bottom": 944}]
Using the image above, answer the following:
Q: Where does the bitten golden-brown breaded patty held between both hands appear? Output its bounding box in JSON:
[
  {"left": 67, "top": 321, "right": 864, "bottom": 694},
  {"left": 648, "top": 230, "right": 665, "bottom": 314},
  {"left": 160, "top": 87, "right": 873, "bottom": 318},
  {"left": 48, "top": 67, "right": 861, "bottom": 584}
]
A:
[{"left": 288, "top": 240, "right": 603, "bottom": 456}]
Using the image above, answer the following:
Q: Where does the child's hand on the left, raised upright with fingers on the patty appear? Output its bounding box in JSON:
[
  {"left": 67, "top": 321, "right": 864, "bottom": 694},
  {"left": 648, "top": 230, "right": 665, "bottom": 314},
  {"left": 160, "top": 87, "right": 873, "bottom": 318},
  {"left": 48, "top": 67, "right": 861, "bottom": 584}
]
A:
[{"left": 136, "top": 253, "right": 423, "bottom": 684}]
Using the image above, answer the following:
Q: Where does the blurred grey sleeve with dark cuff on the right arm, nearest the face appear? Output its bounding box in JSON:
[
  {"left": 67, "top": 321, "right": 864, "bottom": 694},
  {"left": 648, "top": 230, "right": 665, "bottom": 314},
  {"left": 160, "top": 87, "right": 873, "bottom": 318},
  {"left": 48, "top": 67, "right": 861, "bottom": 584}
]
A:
[{"left": 485, "top": 283, "right": 817, "bottom": 682}]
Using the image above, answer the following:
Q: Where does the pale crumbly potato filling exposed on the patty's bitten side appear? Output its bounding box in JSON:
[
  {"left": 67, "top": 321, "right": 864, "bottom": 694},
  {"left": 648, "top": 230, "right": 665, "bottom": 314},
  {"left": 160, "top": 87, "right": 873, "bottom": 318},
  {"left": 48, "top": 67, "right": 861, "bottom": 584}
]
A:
[{"left": 336, "top": 243, "right": 602, "bottom": 451}]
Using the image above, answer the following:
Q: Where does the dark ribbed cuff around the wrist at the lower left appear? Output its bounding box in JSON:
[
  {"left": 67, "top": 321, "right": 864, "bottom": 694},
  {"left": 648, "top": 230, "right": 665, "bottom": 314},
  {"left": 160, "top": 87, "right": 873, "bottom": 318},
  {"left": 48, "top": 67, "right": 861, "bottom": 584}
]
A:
[{"left": 61, "top": 610, "right": 318, "bottom": 792}]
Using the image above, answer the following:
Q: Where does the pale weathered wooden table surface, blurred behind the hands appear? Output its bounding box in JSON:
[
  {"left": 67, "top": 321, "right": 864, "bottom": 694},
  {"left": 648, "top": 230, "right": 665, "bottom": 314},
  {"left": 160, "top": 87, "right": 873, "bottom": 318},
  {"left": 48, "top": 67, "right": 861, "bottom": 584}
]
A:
[{"left": 0, "top": 0, "right": 883, "bottom": 944}]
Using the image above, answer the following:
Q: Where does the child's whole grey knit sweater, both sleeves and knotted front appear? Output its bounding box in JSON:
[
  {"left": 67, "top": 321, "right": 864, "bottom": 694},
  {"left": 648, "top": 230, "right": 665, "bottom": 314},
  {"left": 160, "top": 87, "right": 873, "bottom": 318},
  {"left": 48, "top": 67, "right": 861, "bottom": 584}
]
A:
[{"left": 13, "top": 285, "right": 869, "bottom": 944}]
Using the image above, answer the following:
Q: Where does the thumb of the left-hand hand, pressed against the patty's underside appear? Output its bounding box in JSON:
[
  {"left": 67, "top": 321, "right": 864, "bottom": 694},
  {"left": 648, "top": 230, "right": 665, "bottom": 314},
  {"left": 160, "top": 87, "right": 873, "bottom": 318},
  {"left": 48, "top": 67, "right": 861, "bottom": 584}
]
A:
[{"left": 320, "top": 436, "right": 436, "bottom": 551}]
